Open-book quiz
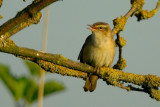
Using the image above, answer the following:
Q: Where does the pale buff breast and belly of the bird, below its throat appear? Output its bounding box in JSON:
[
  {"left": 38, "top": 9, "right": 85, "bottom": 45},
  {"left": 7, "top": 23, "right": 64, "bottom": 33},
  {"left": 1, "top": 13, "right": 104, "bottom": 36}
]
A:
[{"left": 83, "top": 37, "right": 115, "bottom": 67}]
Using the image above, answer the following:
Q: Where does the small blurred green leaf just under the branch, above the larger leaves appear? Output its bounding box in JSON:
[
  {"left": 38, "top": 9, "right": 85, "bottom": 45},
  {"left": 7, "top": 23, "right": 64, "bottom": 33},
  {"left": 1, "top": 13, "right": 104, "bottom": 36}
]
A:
[{"left": 24, "top": 60, "right": 41, "bottom": 76}]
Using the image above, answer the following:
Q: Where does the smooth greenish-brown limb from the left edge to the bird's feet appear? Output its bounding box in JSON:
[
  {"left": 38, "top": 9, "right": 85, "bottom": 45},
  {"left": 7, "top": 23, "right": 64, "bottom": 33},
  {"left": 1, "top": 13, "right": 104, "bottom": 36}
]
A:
[{"left": 0, "top": 40, "right": 95, "bottom": 73}]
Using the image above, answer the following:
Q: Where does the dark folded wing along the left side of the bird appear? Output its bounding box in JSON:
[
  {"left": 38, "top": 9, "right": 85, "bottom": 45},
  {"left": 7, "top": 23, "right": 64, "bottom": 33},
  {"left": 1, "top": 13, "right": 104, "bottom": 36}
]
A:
[{"left": 78, "top": 35, "right": 92, "bottom": 63}]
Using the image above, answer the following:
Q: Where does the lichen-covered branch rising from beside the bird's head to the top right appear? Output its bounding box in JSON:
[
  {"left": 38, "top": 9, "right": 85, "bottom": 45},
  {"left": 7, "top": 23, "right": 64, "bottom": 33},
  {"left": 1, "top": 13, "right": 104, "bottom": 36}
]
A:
[{"left": 112, "top": 0, "right": 160, "bottom": 36}]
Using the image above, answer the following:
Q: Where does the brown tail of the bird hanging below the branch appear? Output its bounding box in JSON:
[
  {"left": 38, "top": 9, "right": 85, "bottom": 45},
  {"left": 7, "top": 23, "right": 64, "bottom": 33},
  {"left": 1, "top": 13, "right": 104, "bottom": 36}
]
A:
[{"left": 83, "top": 75, "right": 98, "bottom": 92}]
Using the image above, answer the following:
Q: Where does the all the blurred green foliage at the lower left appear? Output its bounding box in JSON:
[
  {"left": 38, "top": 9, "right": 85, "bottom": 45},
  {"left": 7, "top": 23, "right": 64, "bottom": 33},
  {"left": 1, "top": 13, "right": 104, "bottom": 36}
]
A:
[{"left": 0, "top": 61, "right": 65, "bottom": 104}]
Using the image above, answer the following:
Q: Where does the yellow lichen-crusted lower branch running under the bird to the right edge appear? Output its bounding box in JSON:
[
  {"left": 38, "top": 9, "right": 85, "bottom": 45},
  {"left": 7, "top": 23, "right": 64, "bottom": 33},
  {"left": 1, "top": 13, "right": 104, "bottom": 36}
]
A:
[{"left": 35, "top": 59, "right": 160, "bottom": 101}]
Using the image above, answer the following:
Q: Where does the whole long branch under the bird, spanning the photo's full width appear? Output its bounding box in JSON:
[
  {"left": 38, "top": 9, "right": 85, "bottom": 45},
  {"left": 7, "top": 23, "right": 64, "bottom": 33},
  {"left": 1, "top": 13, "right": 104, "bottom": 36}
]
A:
[{"left": 0, "top": 40, "right": 160, "bottom": 101}]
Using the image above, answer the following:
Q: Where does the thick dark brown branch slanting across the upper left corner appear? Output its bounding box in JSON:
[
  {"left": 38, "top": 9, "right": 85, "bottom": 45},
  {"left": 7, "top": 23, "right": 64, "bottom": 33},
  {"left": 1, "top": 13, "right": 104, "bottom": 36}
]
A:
[{"left": 0, "top": 0, "right": 58, "bottom": 39}]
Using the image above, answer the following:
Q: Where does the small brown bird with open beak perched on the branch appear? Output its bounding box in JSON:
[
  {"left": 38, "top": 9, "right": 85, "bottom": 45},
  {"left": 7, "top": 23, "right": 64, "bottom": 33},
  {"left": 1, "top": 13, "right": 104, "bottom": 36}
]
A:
[{"left": 78, "top": 22, "right": 116, "bottom": 92}]
